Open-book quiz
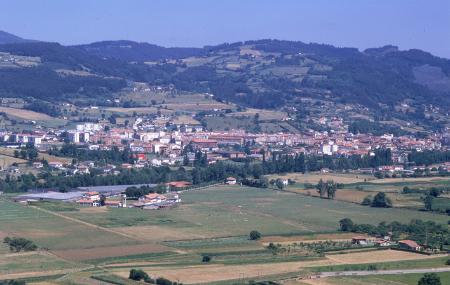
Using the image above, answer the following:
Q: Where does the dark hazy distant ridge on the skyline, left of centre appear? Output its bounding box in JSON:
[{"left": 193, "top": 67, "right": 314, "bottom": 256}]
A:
[{"left": 75, "top": 41, "right": 204, "bottom": 61}]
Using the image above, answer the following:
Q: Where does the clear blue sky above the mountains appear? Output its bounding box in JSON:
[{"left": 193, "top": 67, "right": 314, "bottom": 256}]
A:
[{"left": 0, "top": 0, "right": 450, "bottom": 58}]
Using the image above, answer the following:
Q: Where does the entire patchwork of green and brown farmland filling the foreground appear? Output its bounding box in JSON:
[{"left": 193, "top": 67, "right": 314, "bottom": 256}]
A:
[{"left": 0, "top": 185, "right": 447, "bottom": 285}]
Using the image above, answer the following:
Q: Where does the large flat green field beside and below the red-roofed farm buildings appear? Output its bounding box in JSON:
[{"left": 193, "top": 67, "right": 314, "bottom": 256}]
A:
[{"left": 67, "top": 186, "right": 448, "bottom": 235}]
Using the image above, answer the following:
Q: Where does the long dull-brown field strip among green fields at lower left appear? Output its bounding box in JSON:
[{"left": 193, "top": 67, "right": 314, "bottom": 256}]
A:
[{"left": 52, "top": 244, "right": 171, "bottom": 261}]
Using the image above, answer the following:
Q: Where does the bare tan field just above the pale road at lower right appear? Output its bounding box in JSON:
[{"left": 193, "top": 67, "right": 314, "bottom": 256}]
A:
[{"left": 326, "top": 249, "right": 436, "bottom": 264}]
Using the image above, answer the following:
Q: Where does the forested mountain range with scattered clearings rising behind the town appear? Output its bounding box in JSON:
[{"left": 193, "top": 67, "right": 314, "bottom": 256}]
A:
[{"left": 0, "top": 33, "right": 450, "bottom": 123}]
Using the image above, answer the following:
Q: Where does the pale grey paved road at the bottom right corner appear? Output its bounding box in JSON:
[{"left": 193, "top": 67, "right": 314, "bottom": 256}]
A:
[{"left": 311, "top": 266, "right": 450, "bottom": 278}]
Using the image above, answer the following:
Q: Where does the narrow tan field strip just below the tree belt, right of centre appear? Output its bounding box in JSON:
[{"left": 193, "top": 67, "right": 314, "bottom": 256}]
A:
[{"left": 266, "top": 173, "right": 375, "bottom": 184}]
